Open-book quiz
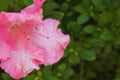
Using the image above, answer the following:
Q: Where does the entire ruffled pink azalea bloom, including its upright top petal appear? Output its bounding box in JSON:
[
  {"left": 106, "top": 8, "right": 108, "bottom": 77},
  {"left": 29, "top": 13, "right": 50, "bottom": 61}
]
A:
[{"left": 0, "top": 0, "right": 70, "bottom": 79}]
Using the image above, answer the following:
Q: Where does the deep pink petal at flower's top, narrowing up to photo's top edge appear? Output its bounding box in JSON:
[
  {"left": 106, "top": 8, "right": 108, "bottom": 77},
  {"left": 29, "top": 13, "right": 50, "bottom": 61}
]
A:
[{"left": 21, "top": 0, "right": 45, "bottom": 20}]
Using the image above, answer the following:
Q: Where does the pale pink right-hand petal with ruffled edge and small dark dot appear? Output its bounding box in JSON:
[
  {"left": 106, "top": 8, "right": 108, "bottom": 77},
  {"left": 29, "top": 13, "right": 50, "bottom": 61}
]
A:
[{"left": 32, "top": 19, "right": 70, "bottom": 65}]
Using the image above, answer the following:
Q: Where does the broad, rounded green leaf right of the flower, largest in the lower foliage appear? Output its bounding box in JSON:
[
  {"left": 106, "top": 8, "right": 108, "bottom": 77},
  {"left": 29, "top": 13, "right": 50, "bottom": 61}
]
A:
[{"left": 80, "top": 49, "right": 96, "bottom": 61}]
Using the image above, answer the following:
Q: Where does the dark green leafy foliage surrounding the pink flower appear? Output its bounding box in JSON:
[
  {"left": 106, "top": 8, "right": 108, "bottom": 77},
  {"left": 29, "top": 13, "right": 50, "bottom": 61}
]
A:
[{"left": 0, "top": 0, "right": 120, "bottom": 80}]
